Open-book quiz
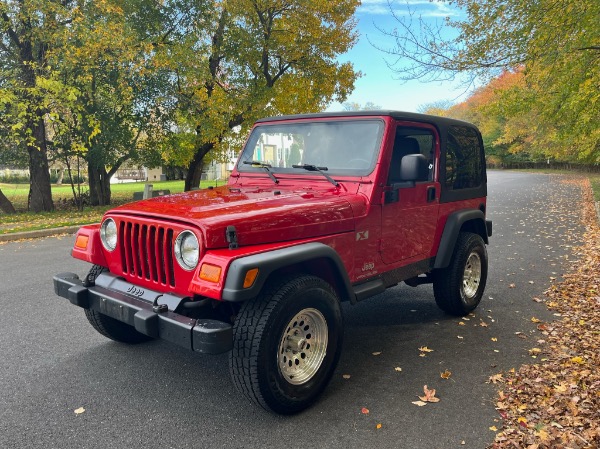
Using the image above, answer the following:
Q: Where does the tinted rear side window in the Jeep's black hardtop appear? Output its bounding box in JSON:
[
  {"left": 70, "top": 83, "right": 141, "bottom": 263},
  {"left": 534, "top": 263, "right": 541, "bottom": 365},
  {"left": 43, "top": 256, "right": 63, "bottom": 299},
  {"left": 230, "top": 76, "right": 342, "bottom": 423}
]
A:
[{"left": 445, "top": 126, "right": 483, "bottom": 190}]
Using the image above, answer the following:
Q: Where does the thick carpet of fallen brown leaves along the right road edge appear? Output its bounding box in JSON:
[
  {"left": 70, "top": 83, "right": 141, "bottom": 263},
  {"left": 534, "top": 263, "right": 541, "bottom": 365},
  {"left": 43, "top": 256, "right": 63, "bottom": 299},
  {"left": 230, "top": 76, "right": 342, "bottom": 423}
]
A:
[{"left": 490, "top": 179, "right": 600, "bottom": 449}]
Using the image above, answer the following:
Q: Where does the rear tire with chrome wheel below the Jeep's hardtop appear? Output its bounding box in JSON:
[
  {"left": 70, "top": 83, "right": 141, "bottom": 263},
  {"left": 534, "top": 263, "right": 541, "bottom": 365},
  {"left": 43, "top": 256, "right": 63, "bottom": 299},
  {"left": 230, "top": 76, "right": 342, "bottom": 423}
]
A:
[{"left": 433, "top": 232, "right": 488, "bottom": 316}]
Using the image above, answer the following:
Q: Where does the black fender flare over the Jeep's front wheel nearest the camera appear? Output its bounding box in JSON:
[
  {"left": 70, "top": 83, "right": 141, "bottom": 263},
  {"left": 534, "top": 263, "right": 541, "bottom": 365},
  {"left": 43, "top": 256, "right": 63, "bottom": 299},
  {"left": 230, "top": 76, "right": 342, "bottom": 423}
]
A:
[{"left": 222, "top": 242, "right": 355, "bottom": 302}]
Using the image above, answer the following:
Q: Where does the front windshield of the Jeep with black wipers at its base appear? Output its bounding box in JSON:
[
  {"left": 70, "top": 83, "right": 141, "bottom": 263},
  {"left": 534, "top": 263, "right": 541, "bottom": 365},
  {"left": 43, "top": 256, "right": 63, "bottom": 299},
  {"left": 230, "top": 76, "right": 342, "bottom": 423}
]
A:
[{"left": 237, "top": 119, "right": 384, "bottom": 176}]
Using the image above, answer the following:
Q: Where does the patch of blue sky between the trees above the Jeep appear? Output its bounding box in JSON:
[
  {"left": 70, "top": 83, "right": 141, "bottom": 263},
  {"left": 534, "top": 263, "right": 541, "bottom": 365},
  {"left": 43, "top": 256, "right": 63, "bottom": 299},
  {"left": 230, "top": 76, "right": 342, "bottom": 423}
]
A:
[{"left": 328, "top": 0, "right": 472, "bottom": 112}]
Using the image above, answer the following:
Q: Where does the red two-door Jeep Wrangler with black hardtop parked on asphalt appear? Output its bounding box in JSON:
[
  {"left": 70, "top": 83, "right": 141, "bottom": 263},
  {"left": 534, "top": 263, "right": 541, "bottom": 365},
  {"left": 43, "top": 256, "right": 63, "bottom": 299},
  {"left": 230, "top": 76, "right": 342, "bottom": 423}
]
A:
[{"left": 54, "top": 111, "right": 492, "bottom": 414}]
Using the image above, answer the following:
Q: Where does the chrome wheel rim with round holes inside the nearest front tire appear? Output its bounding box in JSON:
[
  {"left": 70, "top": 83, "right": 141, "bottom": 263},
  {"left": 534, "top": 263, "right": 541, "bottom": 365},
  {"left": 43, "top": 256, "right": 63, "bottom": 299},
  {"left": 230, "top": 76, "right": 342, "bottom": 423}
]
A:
[{"left": 277, "top": 309, "right": 328, "bottom": 385}]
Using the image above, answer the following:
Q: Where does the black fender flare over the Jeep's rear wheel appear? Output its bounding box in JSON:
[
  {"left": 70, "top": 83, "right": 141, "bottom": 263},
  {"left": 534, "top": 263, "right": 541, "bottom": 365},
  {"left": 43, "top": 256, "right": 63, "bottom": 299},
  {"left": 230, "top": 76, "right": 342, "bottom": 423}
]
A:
[{"left": 433, "top": 209, "right": 491, "bottom": 268}]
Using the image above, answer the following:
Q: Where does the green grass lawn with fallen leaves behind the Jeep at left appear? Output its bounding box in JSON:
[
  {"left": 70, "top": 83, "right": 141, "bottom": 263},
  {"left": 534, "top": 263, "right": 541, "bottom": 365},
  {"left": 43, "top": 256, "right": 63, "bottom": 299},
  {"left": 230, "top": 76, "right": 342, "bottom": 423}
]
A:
[{"left": 0, "top": 181, "right": 223, "bottom": 234}]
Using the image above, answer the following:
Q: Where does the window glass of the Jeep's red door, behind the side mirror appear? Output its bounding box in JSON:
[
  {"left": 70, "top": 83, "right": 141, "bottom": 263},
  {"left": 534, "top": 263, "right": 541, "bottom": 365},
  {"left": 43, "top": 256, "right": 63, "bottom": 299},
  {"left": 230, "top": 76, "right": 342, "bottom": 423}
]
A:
[{"left": 388, "top": 126, "right": 435, "bottom": 183}]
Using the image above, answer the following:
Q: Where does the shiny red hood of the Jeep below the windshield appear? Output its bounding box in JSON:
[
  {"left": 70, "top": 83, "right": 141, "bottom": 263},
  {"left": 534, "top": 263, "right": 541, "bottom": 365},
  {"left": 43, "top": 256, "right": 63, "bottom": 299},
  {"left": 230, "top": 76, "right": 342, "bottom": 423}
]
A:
[{"left": 108, "top": 186, "right": 355, "bottom": 248}]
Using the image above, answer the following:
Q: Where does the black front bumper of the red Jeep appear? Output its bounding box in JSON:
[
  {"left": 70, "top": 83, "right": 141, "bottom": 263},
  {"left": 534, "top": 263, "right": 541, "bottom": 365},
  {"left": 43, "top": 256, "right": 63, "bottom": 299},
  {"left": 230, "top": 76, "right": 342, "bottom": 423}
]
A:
[{"left": 53, "top": 273, "right": 233, "bottom": 354}]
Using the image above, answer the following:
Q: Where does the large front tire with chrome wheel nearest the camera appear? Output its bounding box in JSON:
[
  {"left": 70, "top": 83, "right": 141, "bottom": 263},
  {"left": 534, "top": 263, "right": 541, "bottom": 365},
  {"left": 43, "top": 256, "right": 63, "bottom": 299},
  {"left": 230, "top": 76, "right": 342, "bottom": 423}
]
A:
[{"left": 229, "top": 275, "right": 343, "bottom": 414}]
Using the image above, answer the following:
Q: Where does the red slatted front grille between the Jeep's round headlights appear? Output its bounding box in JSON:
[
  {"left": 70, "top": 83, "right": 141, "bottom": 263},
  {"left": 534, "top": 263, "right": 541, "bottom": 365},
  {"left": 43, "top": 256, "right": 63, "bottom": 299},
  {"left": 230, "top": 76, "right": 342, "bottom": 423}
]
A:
[{"left": 119, "top": 221, "right": 175, "bottom": 287}]
